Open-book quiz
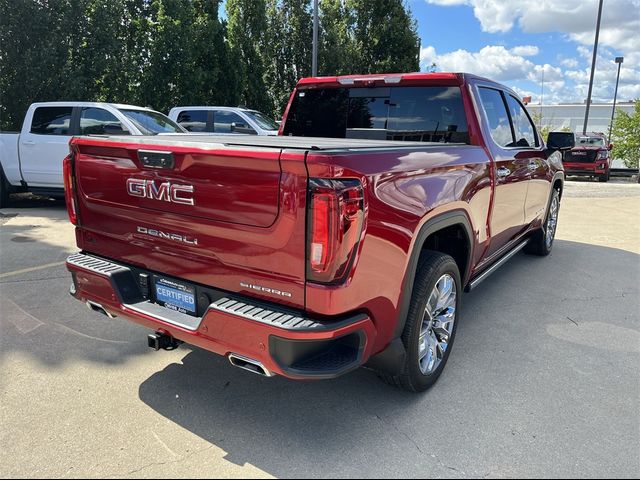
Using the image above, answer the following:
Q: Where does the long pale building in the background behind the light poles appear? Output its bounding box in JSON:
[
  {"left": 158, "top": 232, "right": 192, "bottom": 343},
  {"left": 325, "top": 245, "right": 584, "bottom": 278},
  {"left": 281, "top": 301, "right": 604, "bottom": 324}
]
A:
[{"left": 527, "top": 102, "right": 634, "bottom": 134}]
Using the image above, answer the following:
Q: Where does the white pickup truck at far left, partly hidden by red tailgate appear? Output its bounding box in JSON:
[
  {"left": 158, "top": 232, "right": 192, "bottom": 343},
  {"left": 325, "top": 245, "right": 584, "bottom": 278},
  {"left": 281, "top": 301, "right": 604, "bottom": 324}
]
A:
[{"left": 0, "top": 102, "right": 186, "bottom": 208}]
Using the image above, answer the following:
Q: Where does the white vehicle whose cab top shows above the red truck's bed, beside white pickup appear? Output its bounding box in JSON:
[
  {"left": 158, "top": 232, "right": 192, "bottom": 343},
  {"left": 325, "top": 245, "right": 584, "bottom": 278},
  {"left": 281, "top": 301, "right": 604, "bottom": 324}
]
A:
[{"left": 169, "top": 106, "right": 279, "bottom": 135}]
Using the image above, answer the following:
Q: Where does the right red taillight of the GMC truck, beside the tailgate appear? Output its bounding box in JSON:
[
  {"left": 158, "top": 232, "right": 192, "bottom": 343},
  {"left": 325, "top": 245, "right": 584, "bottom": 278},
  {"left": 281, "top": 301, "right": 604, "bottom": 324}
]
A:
[{"left": 307, "top": 178, "right": 365, "bottom": 283}]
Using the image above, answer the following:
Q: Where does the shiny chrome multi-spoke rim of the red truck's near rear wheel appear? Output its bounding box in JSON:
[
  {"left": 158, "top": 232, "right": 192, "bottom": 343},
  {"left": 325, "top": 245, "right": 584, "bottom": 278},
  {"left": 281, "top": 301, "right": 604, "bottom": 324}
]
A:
[{"left": 418, "top": 274, "right": 457, "bottom": 375}]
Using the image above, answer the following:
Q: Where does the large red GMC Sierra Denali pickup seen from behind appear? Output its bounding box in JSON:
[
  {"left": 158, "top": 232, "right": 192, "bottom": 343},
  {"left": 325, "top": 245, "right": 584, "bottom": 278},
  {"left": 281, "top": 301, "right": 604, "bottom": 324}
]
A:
[{"left": 64, "top": 74, "right": 571, "bottom": 391}]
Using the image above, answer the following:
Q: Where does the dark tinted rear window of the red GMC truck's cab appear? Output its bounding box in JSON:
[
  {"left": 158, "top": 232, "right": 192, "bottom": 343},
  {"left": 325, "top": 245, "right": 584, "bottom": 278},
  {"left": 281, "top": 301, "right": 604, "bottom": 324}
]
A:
[{"left": 284, "top": 87, "right": 469, "bottom": 143}]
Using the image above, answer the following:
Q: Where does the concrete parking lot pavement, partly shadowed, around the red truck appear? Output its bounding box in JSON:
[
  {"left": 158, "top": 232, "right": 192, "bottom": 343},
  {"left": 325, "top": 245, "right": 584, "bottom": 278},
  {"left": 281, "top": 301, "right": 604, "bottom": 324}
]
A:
[{"left": 0, "top": 180, "right": 640, "bottom": 478}]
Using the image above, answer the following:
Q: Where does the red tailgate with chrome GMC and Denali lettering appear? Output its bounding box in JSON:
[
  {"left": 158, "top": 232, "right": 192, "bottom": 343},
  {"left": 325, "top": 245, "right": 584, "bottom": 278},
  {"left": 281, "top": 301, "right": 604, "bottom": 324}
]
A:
[{"left": 71, "top": 137, "right": 307, "bottom": 308}]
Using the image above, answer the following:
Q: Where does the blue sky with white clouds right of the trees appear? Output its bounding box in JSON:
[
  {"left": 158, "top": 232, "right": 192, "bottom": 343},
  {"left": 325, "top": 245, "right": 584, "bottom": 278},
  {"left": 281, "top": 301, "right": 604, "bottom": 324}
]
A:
[{"left": 408, "top": 0, "right": 640, "bottom": 103}]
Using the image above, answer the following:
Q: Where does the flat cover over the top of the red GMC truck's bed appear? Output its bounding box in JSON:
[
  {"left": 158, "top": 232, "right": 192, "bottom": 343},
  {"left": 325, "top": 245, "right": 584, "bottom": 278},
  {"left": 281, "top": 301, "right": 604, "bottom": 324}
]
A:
[{"left": 73, "top": 135, "right": 467, "bottom": 150}]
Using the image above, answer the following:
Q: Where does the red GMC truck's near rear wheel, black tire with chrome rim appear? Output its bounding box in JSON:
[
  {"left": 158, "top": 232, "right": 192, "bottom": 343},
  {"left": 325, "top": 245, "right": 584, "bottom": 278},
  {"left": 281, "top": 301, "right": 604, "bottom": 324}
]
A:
[{"left": 379, "top": 250, "right": 462, "bottom": 392}]
